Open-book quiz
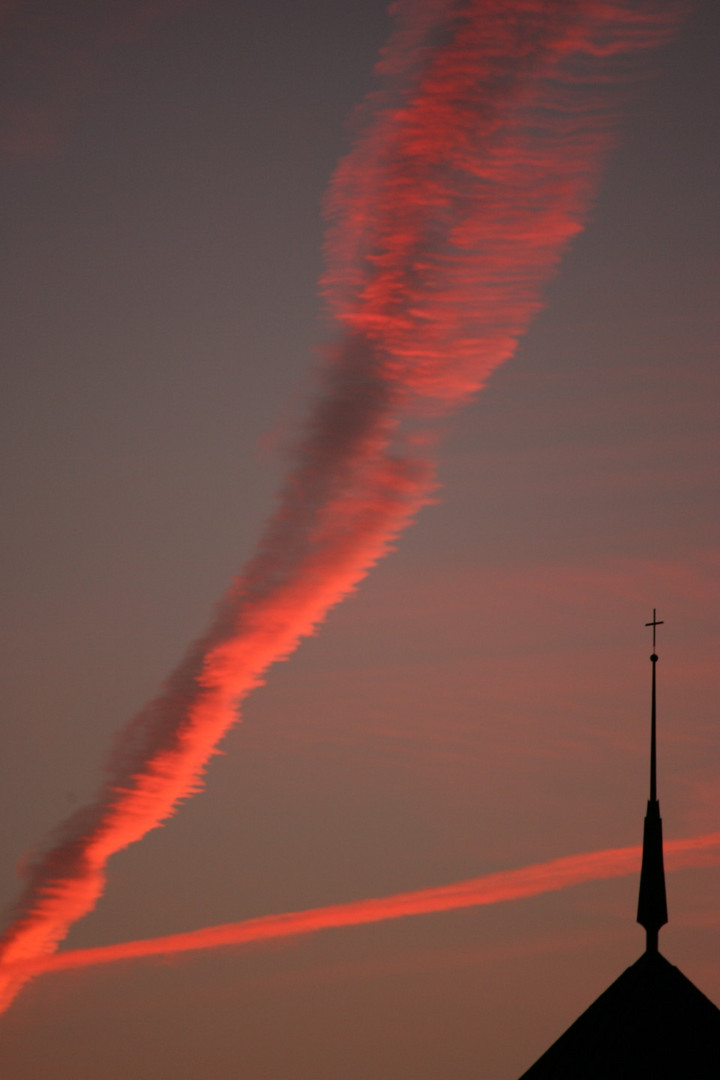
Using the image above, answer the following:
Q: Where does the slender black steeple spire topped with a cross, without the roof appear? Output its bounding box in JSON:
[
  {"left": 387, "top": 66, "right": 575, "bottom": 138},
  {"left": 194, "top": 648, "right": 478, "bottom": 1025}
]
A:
[{"left": 638, "top": 608, "right": 667, "bottom": 953}]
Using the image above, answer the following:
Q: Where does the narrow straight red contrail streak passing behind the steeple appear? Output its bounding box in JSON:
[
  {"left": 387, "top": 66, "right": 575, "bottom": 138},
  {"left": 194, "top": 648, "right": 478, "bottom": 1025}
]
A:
[{"left": 8, "top": 833, "right": 720, "bottom": 989}]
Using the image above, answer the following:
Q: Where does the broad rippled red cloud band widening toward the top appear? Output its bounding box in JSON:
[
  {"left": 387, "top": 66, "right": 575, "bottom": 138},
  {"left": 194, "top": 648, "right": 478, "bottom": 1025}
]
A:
[{"left": 0, "top": 0, "right": 673, "bottom": 1003}]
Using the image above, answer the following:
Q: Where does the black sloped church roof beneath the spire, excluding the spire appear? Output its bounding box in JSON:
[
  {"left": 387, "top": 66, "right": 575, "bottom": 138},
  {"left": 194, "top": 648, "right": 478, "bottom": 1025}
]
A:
[{"left": 520, "top": 951, "right": 720, "bottom": 1080}]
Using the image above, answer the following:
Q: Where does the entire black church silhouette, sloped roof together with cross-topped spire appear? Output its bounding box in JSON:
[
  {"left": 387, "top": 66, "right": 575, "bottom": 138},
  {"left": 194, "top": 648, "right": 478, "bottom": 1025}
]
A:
[{"left": 520, "top": 608, "right": 720, "bottom": 1080}]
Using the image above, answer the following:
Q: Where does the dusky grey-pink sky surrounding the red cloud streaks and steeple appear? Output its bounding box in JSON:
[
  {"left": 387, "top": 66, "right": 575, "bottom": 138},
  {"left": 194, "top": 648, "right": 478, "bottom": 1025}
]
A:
[{"left": 0, "top": 0, "right": 720, "bottom": 1080}]
